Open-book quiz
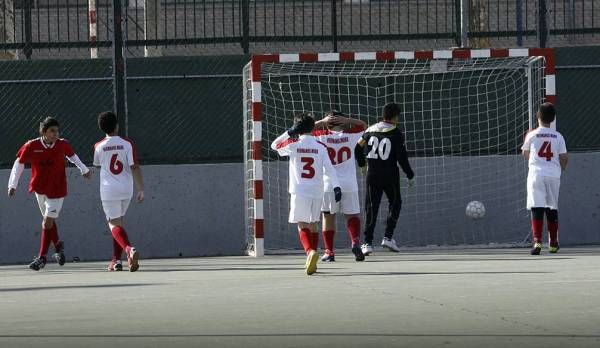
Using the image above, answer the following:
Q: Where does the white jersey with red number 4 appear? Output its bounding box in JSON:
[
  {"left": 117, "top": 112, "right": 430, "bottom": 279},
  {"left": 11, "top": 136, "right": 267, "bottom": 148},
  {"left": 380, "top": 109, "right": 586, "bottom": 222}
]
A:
[{"left": 521, "top": 126, "right": 567, "bottom": 178}]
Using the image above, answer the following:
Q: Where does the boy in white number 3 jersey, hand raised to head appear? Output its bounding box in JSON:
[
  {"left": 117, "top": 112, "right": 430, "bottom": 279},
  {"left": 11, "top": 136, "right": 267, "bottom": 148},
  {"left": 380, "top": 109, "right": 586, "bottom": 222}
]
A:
[{"left": 271, "top": 113, "right": 342, "bottom": 275}]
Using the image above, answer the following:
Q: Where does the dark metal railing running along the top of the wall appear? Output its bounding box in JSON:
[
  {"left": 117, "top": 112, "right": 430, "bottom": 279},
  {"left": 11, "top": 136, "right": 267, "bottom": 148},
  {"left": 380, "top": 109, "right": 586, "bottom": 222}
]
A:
[{"left": 0, "top": 0, "right": 600, "bottom": 58}]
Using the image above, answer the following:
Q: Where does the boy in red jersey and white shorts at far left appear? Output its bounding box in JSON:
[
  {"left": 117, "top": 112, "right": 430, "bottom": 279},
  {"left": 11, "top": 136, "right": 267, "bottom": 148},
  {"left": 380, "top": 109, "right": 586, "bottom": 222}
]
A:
[{"left": 8, "top": 117, "right": 92, "bottom": 271}]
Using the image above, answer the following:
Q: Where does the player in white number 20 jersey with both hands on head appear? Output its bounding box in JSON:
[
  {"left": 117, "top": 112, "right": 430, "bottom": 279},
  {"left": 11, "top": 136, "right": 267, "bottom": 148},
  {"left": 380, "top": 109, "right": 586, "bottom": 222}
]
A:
[{"left": 313, "top": 110, "right": 367, "bottom": 262}]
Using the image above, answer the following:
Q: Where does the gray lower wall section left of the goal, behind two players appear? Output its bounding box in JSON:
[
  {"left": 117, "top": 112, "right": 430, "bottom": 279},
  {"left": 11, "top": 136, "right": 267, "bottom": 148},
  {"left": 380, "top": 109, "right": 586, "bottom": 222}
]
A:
[{"left": 0, "top": 164, "right": 245, "bottom": 263}]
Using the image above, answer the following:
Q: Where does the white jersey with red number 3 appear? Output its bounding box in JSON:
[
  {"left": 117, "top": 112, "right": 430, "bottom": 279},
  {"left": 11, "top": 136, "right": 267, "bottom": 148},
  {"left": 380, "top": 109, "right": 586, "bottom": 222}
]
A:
[{"left": 271, "top": 132, "right": 339, "bottom": 199}]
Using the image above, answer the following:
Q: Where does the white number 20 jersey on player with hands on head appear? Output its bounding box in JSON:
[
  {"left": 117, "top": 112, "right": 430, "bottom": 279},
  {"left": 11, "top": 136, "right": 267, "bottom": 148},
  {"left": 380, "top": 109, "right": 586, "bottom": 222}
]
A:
[{"left": 313, "top": 126, "right": 365, "bottom": 192}]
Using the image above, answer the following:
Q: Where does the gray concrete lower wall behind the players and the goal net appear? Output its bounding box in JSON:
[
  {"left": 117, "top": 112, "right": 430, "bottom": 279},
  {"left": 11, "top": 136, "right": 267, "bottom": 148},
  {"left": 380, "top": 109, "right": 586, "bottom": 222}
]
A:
[{"left": 0, "top": 153, "right": 600, "bottom": 263}]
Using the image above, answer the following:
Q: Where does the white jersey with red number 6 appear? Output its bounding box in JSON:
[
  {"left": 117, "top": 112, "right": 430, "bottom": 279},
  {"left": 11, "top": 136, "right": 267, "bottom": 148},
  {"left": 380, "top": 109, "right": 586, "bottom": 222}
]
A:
[{"left": 94, "top": 136, "right": 138, "bottom": 201}]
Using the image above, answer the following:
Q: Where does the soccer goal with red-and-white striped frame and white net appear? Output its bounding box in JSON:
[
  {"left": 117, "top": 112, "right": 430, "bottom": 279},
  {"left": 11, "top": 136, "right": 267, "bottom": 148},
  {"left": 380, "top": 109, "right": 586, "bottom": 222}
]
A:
[{"left": 243, "top": 49, "right": 555, "bottom": 256}]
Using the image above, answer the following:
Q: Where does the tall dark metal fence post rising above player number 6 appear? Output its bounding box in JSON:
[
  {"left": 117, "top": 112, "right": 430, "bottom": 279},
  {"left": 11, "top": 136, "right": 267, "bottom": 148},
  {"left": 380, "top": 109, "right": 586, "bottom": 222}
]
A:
[{"left": 112, "top": 0, "right": 128, "bottom": 135}]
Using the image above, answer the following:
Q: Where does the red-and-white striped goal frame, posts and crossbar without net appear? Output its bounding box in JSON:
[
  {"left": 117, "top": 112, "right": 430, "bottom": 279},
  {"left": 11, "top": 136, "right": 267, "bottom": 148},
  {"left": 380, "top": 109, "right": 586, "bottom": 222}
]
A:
[{"left": 250, "top": 48, "right": 557, "bottom": 256}]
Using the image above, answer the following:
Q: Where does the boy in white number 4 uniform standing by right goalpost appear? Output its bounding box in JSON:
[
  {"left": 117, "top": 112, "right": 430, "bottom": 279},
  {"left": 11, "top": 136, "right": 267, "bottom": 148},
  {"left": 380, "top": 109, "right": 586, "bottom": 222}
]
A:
[{"left": 521, "top": 103, "right": 568, "bottom": 255}]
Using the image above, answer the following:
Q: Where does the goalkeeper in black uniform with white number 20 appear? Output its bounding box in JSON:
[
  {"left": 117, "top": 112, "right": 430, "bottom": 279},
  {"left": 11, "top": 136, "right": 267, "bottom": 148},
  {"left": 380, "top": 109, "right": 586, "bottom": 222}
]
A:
[{"left": 354, "top": 103, "right": 415, "bottom": 255}]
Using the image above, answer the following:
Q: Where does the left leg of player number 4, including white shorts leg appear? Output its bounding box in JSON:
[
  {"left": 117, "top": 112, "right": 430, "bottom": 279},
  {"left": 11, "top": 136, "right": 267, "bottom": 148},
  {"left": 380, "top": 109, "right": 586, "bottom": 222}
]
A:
[{"left": 527, "top": 176, "right": 546, "bottom": 255}]
